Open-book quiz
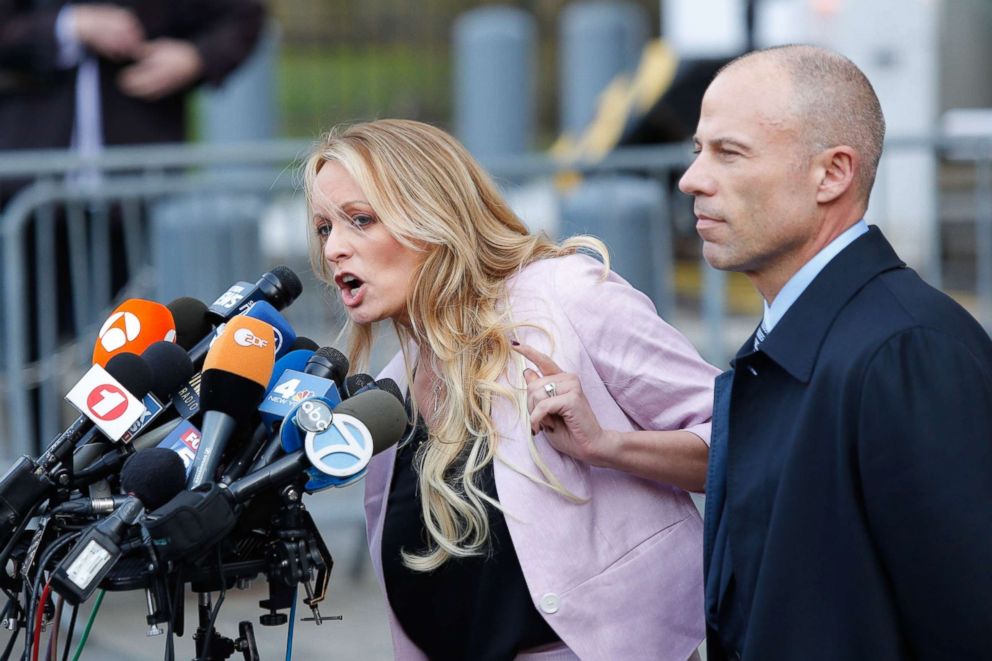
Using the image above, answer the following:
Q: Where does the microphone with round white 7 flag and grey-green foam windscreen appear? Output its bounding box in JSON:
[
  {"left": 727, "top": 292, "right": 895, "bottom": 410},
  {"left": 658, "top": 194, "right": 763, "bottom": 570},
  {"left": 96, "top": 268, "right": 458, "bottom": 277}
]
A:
[{"left": 144, "top": 391, "right": 406, "bottom": 558}]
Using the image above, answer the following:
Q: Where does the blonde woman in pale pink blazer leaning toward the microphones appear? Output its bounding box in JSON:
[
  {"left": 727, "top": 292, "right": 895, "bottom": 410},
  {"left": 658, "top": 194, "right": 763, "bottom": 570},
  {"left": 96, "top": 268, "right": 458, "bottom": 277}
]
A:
[{"left": 306, "top": 120, "right": 717, "bottom": 661}]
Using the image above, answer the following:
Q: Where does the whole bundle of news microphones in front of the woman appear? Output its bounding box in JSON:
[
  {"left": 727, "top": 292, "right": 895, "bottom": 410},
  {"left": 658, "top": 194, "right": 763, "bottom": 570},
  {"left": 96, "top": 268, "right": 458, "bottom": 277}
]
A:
[{"left": 0, "top": 267, "right": 407, "bottom": 658}]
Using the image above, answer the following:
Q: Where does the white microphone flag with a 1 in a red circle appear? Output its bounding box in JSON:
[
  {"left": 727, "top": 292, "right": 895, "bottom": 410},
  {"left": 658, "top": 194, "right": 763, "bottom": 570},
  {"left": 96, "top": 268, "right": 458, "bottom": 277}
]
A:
[{"left": 65, "top": 365, "right": 146, "bottom": 441}]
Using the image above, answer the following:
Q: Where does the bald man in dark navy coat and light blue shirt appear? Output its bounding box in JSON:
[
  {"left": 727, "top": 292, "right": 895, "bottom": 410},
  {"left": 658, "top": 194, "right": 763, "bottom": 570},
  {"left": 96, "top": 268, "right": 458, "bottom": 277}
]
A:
[{"left": 680, "top": 46, "right": 992, "bottom": 661}]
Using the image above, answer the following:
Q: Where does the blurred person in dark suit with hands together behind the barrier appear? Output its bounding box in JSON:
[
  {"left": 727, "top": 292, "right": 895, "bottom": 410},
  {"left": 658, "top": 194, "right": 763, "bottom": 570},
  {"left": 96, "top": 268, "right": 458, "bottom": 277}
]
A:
[{"left": 0, "top": 0, "right": 264, "bottom": 178}]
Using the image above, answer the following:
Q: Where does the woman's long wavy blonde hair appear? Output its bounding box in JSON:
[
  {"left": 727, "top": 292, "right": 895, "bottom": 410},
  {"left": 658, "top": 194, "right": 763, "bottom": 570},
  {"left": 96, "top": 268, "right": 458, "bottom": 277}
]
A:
[{"left": 304, "top": 120, "right": 608, "bottom": 571}]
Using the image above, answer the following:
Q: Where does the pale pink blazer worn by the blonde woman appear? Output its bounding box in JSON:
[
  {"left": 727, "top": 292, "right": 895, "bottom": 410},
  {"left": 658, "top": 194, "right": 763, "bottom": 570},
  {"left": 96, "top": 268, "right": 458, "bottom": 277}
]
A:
[{"left": 365, "top": 255, "right": 718, "bottom": 661}]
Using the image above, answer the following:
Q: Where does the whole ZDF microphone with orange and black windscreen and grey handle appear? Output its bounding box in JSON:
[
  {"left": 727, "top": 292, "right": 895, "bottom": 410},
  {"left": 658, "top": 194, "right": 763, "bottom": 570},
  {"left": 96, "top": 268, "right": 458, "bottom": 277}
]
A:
[{"left": 187, "top": 316, "right": 275, "bottom": 489}]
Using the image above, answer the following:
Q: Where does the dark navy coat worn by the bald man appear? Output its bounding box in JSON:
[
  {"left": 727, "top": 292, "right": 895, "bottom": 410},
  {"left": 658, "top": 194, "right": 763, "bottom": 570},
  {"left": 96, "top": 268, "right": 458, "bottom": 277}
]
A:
[{"left": 705, "top": 228, "right": 992, "bottom": 661}]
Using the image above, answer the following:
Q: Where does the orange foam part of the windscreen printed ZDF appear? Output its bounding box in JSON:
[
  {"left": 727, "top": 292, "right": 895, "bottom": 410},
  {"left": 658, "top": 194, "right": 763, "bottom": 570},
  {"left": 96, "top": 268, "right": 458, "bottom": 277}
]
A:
[{"left": 203, "top": 315, "right": 276, "bottom": 389}]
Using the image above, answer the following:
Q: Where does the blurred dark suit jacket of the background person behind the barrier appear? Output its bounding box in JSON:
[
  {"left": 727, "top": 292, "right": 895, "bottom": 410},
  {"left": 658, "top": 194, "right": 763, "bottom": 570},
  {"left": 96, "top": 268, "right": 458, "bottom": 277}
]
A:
[{"left": 0, "top": 0, "right": 264, "bottom": 150}]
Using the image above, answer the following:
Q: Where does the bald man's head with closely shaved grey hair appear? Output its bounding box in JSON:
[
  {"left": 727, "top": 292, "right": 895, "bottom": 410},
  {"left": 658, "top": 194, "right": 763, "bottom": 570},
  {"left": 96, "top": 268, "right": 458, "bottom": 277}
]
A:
[{"left": 679, "top": 46, "right": 885, "bottom": 300}]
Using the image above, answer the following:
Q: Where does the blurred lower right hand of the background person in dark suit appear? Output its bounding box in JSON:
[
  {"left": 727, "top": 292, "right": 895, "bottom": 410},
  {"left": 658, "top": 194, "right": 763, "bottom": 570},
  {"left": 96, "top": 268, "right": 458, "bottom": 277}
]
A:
[{"left": 117, "top": 38, "right": 203, "bottom": 101}]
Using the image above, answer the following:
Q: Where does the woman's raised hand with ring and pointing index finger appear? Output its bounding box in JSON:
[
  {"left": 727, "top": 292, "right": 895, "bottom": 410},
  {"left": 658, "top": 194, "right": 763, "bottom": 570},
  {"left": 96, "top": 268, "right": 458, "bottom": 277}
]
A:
[{"left": 513, "top": 344, "right": 615, "bottom": 465}]
